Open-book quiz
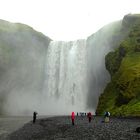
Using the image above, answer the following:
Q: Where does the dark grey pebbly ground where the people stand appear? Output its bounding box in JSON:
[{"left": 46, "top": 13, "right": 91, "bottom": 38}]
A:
[{"left": 0, "top": 116, "right": 140, "bottom": 140}]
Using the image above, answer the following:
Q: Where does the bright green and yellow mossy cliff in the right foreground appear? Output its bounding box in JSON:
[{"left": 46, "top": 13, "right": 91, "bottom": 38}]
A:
[{"left": 97, "top": 15, "right": 140, "bottom": 116}]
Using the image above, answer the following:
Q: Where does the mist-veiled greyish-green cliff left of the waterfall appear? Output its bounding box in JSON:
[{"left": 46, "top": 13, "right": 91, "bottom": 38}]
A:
[{"left": 0, "top": 20, "right": 50, "bottom": 113}]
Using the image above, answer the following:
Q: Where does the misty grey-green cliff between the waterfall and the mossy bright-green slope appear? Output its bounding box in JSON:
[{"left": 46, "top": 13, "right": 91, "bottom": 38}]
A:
[{"left": 86, "top": 21, "right": 126, "bottom": 110}]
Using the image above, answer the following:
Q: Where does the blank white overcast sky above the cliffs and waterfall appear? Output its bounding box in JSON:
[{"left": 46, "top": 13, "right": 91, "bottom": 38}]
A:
[{"left": 0, "top": 0, "right": 140, "bottom": 40}]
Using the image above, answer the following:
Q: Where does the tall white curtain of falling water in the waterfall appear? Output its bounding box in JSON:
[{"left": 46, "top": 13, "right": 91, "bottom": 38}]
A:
[{"left": 43, "top": 40, "right": 88, "bottom": 113}]
